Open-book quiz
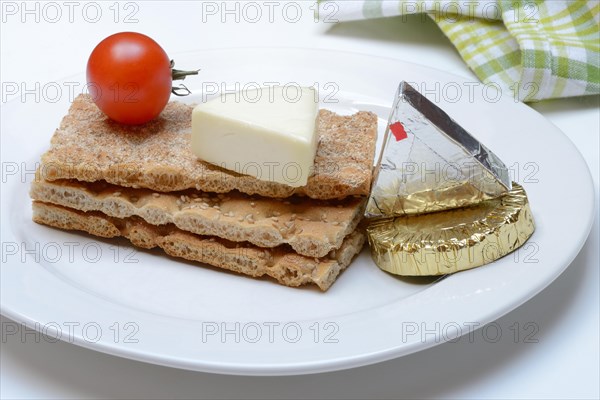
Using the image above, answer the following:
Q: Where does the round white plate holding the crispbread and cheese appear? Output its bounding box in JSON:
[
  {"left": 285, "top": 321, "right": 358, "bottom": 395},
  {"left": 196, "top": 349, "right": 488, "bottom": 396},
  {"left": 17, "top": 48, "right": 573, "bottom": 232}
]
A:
[{"left": 1, "top": 49, "right": 593, "bottom": 375}]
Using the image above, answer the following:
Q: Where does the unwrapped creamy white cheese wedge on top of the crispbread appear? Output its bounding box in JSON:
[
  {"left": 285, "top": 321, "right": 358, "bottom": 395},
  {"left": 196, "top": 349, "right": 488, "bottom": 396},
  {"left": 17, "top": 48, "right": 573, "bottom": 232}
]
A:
[{"left": 192, "top": 86, "right": 318, "bottom": 187}]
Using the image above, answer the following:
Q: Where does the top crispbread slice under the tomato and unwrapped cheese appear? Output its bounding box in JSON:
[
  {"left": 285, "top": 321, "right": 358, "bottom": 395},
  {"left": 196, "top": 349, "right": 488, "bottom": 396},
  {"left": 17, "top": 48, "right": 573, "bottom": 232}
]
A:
[{"left": 41, "top": 95, "right": 377, "bottom": 199}]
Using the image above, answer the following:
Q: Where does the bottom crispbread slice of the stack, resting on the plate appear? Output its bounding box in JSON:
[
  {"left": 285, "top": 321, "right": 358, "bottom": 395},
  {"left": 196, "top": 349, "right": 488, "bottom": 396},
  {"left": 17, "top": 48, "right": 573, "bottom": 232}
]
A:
[{"left": 33, "top": 201, "right": 365, "bottom": 291}]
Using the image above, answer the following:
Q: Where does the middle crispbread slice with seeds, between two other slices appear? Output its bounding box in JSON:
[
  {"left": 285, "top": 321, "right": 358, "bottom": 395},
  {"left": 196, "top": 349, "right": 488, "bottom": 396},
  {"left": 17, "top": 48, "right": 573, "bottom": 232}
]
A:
[{"left": 30, "top": 174, "right": 366, "bottom": 257}]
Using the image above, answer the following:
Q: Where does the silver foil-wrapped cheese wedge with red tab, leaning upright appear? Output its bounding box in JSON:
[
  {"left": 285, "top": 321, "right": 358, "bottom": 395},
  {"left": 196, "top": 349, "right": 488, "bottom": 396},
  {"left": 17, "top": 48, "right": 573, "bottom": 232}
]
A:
[{"left": 365, "top": 82, "right": 511, "bottom": 217}]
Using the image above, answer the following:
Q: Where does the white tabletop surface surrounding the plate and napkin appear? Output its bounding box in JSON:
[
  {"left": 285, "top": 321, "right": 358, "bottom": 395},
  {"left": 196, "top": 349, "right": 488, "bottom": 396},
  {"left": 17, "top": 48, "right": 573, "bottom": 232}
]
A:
[{"left": 0, "top": 1, "right": 600, "bottom": 399}]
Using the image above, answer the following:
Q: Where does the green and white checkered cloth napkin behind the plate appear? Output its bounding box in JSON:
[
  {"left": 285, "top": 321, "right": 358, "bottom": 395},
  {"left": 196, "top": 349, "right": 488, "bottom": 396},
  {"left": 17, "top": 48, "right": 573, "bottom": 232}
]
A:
[{"left": 319, "top": 0, "right": 600, "bottom": 101}]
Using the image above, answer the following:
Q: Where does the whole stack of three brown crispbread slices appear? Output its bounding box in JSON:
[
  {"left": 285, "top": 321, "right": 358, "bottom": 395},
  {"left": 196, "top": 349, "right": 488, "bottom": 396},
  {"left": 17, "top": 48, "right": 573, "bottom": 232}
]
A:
[{"left": 31, "top": 95, "right": 377, "bottom": 290}]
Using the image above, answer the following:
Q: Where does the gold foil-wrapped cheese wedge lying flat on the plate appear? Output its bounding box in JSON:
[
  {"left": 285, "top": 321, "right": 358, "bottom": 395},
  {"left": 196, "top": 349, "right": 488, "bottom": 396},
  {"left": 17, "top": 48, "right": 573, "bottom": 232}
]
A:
[{"left": 367, "top": 182, "right": 535, "bottom": 276}]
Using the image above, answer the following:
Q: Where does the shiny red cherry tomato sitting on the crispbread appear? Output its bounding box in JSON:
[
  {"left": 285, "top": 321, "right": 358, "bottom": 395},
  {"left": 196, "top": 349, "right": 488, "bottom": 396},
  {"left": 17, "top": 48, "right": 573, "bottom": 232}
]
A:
[{"left": 87, "top": 32, "right": 197, "bottom": 125}]
